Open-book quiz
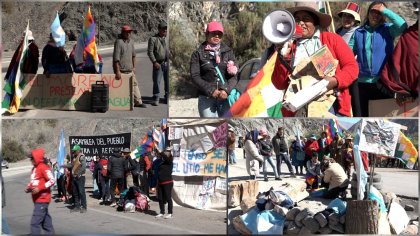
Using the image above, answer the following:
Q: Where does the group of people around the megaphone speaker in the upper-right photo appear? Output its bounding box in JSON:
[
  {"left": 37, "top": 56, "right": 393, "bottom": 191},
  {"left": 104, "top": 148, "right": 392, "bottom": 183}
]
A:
[{"left": 190, "top": 1, "right": 418, "bottom": 117}]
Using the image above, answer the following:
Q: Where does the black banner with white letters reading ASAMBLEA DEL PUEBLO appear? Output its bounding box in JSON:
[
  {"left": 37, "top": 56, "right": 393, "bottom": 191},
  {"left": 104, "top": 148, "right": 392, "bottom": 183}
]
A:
[{"left": 69, "top": 133, "right": 131, "bottom": 162}]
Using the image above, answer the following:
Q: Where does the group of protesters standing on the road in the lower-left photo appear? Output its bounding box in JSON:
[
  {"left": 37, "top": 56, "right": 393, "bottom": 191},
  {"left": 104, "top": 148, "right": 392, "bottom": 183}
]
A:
[{"left": 25, "top": 145, "right": 173, "bottom": 234}]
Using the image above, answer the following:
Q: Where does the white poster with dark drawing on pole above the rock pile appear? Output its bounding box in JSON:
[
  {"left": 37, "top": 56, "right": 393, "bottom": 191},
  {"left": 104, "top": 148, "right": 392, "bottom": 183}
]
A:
[{"left": 359, "top": 119, "right": 400, "bottom": 157}]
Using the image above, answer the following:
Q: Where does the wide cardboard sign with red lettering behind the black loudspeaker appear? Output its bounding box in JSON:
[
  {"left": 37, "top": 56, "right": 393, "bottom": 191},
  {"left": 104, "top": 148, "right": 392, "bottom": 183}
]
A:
[{"left": 20, "top": 73, "right": 133, "bottom": 111}]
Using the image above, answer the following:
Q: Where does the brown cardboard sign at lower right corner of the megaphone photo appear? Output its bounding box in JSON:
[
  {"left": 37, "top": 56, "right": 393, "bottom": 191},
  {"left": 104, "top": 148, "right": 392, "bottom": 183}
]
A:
[{"left": 369, "top": 98, "right": 419, "bottom": 117}]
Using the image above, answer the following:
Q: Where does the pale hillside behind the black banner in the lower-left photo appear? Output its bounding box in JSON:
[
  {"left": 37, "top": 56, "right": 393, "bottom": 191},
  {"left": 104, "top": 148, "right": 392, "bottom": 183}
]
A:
[{"left": 1, "top": 119, "right": 160, "bottom": 160}]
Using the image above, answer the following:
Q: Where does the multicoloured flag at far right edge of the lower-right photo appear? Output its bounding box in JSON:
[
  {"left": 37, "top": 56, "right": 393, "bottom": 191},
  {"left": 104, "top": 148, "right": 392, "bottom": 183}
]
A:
[{"left": 394, "top": 131, "right": 419, "bottom": 169}]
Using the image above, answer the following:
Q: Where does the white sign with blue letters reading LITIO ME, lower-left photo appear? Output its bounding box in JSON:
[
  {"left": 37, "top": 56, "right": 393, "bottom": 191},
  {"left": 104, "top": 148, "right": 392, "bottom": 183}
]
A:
[{"left": 172, "top": 148, "right": 226, "bottom": 178}]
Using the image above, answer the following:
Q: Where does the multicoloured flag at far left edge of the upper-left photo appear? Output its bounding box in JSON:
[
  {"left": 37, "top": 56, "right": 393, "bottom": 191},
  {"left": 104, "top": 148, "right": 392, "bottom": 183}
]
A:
[{"left": 1, "top": 22, "right": 29, "bottom": 114}]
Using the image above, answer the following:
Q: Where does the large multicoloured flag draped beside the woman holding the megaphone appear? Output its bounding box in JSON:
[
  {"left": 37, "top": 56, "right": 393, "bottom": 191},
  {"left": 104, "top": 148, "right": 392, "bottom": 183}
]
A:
[{"left": 225, "top": 51, "right": 284, "bottom": 117}]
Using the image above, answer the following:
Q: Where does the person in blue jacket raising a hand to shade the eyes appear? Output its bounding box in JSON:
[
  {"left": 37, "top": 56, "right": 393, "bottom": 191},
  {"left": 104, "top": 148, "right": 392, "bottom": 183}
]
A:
[{"left": 349, "top": 1, "right": 408, "bottom": 117}]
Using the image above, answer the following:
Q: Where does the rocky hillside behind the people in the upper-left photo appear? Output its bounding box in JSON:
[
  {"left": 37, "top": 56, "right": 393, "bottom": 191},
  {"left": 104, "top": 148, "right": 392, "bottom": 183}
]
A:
[{"left": 2, "top": 1, "right": 167, "bottom": 50}]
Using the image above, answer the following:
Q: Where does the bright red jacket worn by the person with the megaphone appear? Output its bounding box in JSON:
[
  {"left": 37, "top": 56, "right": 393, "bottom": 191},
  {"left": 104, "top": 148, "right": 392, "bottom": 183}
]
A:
[{"left": 272, "top": 32, "right": 359, "bottom": 116}]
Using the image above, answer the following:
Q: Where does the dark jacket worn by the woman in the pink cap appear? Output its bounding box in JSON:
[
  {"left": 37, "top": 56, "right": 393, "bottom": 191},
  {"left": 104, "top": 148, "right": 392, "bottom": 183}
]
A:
[{"left": 190, "top": 42, "right": 238, "bottom": 97}]
